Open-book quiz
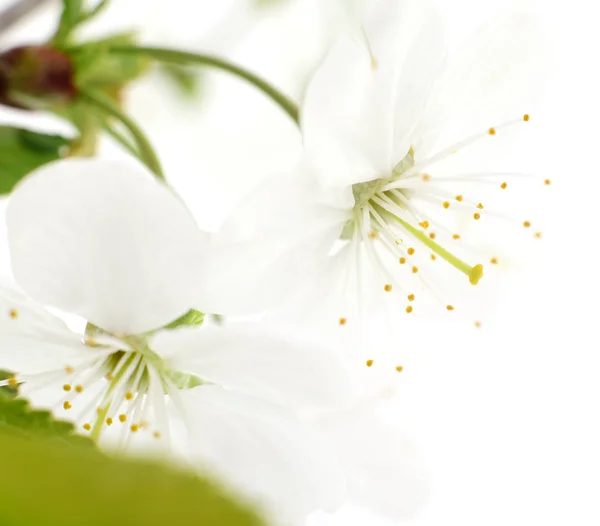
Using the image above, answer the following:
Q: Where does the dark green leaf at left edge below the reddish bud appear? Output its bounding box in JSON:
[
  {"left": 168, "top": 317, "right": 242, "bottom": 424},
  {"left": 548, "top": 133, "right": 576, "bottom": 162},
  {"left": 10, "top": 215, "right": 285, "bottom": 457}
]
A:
[{"left": 0, "top": 126, "right": 69, "bottom": 195}]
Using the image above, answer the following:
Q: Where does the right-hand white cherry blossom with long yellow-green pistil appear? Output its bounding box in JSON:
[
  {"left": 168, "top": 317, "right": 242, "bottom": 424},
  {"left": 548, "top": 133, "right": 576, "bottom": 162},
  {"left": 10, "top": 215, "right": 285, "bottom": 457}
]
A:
[{"left": 216, "top": 0, "right": 550, "bottom": 325}]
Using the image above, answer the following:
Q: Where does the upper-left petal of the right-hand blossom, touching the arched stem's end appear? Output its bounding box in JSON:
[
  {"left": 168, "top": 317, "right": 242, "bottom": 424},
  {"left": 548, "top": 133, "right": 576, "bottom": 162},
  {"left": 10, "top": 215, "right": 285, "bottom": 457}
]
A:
[{"left": 301, "top": 37, "right": 393, "bottom": 186}]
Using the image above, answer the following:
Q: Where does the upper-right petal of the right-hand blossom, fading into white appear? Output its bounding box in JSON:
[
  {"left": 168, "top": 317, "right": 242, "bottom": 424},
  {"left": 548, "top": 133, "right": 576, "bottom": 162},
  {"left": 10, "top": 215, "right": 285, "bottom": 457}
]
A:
[{"left": 413, "top": 11, "right": 550, "bottom": 160}]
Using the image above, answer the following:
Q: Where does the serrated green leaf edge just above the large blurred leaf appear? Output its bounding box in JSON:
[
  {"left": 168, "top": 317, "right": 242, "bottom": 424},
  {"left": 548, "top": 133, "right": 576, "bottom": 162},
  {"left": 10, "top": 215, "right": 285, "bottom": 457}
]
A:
[{"left": 0, "top": 391, "right": 94, "bottom": 447}]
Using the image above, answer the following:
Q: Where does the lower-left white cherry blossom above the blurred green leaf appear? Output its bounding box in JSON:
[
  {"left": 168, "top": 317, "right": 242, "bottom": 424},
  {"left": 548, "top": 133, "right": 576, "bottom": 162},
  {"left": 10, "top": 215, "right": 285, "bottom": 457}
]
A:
[{"left": 0, "top": 160, "right": 352, "bottom": 520}]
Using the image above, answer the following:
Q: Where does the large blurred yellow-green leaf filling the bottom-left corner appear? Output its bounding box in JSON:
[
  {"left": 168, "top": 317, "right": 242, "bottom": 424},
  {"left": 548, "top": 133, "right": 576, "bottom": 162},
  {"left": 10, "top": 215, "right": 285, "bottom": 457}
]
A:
[{"left": 0, "top": 435, "right": 264, "bottom": 526}]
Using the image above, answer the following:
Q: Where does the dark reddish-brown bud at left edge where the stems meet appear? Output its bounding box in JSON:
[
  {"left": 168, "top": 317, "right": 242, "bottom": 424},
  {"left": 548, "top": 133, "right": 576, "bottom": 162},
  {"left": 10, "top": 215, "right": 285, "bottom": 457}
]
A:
[{"left": 0, "top": 46, "right": 77, "bottom": 110}]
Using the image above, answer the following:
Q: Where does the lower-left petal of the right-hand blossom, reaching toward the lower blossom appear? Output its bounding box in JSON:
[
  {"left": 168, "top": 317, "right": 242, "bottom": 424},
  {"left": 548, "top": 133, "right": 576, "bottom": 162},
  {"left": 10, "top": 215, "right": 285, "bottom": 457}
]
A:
[{"left": 199, "top": 168, "right": 352, "bottom": 315}]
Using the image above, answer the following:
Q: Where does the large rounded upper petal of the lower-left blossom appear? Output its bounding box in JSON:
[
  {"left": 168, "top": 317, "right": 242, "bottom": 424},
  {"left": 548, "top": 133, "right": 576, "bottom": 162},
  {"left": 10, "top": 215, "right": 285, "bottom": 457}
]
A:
[{"left": 7, "top": 159, "right": 207, "bottom": 334}]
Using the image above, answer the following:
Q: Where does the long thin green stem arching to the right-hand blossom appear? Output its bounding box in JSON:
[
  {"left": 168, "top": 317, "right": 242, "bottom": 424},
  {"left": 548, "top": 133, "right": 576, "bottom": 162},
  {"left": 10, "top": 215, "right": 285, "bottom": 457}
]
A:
[{"left": 107, "top": 45, "right": 300, "bottom": 124}]
